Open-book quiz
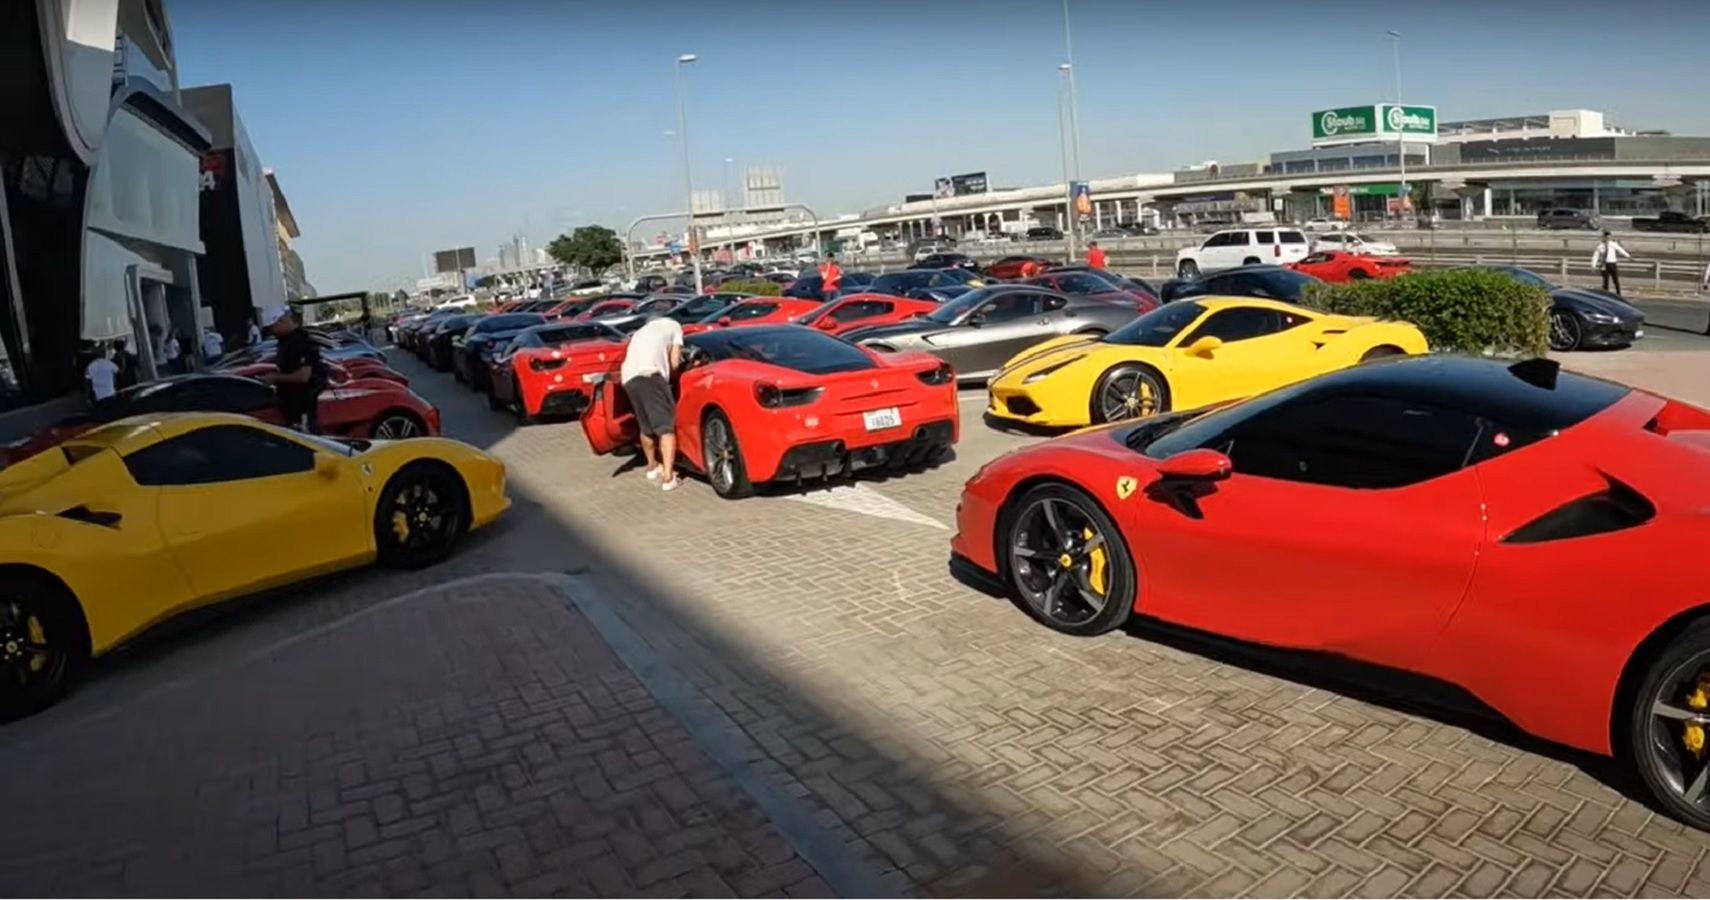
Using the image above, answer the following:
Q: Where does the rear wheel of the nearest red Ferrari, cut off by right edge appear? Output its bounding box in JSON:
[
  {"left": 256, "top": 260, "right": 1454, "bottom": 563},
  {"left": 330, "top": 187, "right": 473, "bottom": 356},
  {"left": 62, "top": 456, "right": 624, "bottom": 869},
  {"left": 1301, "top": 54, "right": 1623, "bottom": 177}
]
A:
[{"left": 1616, "top": 618, "right": 1710, "bottom": 830}]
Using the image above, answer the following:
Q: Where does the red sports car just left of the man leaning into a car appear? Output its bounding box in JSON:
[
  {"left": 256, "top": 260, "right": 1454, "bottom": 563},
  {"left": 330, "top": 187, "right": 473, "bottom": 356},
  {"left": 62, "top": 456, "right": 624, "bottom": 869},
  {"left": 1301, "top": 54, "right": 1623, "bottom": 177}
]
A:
[{"left": 487, "top": 322, "right": 629, "bottom": 424}]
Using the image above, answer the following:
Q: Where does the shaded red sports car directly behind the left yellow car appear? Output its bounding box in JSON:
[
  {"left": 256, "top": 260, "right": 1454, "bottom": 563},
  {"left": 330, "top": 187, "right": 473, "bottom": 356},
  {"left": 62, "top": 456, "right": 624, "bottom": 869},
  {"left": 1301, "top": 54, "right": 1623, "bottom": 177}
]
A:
[{"left": 7, "top": 375, "right": 439, "bottom": 462}]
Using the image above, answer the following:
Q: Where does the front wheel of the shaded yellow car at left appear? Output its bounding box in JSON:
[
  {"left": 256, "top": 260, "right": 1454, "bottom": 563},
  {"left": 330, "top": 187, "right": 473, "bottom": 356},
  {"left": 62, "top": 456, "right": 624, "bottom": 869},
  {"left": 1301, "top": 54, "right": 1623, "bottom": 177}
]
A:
[{"left": 374, "top": 462, "right": 469, "bottom": 568}]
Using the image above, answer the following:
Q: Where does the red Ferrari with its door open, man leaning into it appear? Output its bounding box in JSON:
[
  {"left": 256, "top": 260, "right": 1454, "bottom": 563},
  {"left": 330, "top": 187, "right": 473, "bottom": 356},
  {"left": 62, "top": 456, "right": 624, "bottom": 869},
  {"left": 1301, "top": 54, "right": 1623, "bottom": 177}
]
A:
[{"left": 581, "top": 325, "right": 961, "bottom": 498}]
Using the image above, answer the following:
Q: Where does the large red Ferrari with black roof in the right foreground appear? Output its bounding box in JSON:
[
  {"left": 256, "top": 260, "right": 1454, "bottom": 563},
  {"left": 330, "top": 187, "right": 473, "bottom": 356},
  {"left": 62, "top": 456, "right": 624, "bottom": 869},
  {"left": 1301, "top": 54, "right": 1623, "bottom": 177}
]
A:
[{"left": 952, "top": 356, "right": 1710, "bottom": 828}]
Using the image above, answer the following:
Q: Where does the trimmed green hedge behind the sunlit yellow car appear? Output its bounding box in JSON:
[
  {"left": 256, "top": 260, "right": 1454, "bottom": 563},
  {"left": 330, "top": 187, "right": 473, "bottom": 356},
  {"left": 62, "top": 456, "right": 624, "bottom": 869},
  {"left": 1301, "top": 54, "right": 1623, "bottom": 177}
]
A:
[{"left": 1301, "top": 269, "right": 1549, "bottom": 356}]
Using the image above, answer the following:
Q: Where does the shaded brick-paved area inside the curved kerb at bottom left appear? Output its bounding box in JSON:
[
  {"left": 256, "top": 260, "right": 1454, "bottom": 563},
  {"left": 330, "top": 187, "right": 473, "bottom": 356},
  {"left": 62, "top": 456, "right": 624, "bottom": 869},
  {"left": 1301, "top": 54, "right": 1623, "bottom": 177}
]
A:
[{"left": 0, "top": 578, "right": 829, "bottom": 897}]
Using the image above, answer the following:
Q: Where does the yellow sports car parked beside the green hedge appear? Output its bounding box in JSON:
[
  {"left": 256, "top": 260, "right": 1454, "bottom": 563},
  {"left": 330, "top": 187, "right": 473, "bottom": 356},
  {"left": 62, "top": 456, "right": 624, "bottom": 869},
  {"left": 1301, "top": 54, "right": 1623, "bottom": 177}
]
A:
[{"left": 987, "top": 298, "right": 1426, "bottom": 428}]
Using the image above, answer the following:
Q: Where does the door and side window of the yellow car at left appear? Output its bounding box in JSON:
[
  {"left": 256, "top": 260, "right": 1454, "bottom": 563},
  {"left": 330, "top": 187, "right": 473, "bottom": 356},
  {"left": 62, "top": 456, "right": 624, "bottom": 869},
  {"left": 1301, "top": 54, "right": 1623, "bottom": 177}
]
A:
[{"left": 125, "top": 424, "right": 373, "bottom": 601}]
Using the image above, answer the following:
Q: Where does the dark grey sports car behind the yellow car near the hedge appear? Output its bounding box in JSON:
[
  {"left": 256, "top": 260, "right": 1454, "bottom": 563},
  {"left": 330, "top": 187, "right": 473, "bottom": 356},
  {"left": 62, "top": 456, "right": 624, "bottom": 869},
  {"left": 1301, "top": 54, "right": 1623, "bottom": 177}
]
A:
[{"left": 843, "top": 284, "right": 1139, "bottom": 382}]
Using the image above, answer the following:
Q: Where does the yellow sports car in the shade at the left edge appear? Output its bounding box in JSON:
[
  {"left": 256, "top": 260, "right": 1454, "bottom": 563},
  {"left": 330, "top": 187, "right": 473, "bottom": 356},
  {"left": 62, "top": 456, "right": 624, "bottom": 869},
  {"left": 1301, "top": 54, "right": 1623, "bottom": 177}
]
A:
[{"left": 0, "top": 412, "right": 510, "bottom": 720}]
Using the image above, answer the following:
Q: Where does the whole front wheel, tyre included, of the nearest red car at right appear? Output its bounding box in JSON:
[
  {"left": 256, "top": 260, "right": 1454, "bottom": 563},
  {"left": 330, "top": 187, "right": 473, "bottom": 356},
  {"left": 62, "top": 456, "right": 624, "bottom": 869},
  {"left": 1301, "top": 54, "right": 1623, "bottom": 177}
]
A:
[{"left": 997, "top": 483, "right": 1137, "bottom": 637}]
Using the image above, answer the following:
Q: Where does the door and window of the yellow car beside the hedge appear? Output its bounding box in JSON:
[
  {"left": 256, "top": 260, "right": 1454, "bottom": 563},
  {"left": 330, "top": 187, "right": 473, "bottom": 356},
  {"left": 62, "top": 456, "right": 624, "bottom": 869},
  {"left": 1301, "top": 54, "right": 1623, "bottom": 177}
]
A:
[{"left": 1165, "top": 306, "right": 1313, "bottom": 409}]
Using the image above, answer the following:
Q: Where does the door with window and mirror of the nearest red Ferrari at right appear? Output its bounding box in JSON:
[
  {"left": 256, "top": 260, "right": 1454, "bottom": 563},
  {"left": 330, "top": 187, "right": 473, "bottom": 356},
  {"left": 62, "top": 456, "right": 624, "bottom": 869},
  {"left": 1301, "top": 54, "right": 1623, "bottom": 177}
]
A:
[{"left": 1118, "top": 392, "right": 1484, "bottom": 667}]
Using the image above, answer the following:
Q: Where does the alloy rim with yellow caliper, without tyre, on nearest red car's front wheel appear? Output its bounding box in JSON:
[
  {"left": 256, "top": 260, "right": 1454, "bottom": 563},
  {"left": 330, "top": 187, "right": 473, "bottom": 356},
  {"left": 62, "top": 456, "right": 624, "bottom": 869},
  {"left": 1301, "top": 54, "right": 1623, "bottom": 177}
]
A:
[{"left": 1009, "top": 496, "right": 1112, "bottom": 628}]
